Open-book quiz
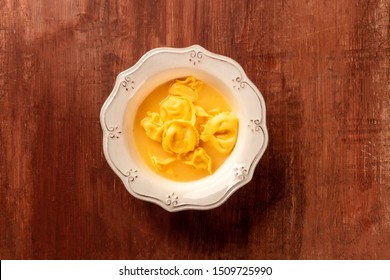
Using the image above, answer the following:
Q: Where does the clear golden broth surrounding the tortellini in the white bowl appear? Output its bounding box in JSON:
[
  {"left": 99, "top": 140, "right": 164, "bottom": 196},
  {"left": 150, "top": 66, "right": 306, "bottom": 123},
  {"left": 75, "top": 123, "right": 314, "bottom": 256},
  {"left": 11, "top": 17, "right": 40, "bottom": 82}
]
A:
[{"left": 133, "top": 76, "right": 238, "bottom": 182}]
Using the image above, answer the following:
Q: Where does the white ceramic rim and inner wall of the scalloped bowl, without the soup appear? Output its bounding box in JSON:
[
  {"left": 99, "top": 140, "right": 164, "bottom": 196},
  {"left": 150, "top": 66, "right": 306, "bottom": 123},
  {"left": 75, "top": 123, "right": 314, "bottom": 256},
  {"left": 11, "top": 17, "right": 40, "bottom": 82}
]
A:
[{"left": 100, "top": 45, "right": 268, "bottom": 212}]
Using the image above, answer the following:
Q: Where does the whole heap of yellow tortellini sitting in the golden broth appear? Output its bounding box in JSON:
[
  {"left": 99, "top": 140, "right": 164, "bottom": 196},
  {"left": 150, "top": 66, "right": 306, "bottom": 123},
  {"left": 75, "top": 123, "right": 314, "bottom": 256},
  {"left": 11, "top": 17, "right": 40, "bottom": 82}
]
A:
[{"left": 140, "top": 76, "right": 238, "bottom": 177}]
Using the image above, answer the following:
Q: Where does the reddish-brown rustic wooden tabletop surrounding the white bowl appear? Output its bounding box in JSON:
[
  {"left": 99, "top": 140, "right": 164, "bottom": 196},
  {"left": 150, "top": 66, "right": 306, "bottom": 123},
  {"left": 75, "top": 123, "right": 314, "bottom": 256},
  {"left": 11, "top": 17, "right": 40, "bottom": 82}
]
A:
[{"left": 0, "top": 0, "right": 390, "bottom": 259}]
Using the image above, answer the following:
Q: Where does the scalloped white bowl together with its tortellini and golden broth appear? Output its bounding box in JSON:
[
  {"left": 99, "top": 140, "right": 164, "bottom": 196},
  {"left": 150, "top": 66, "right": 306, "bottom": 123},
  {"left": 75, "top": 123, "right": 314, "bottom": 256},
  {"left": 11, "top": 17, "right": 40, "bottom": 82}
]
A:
[{"left": 101, "top": 45, "right": 268, "bottom": 211}]
